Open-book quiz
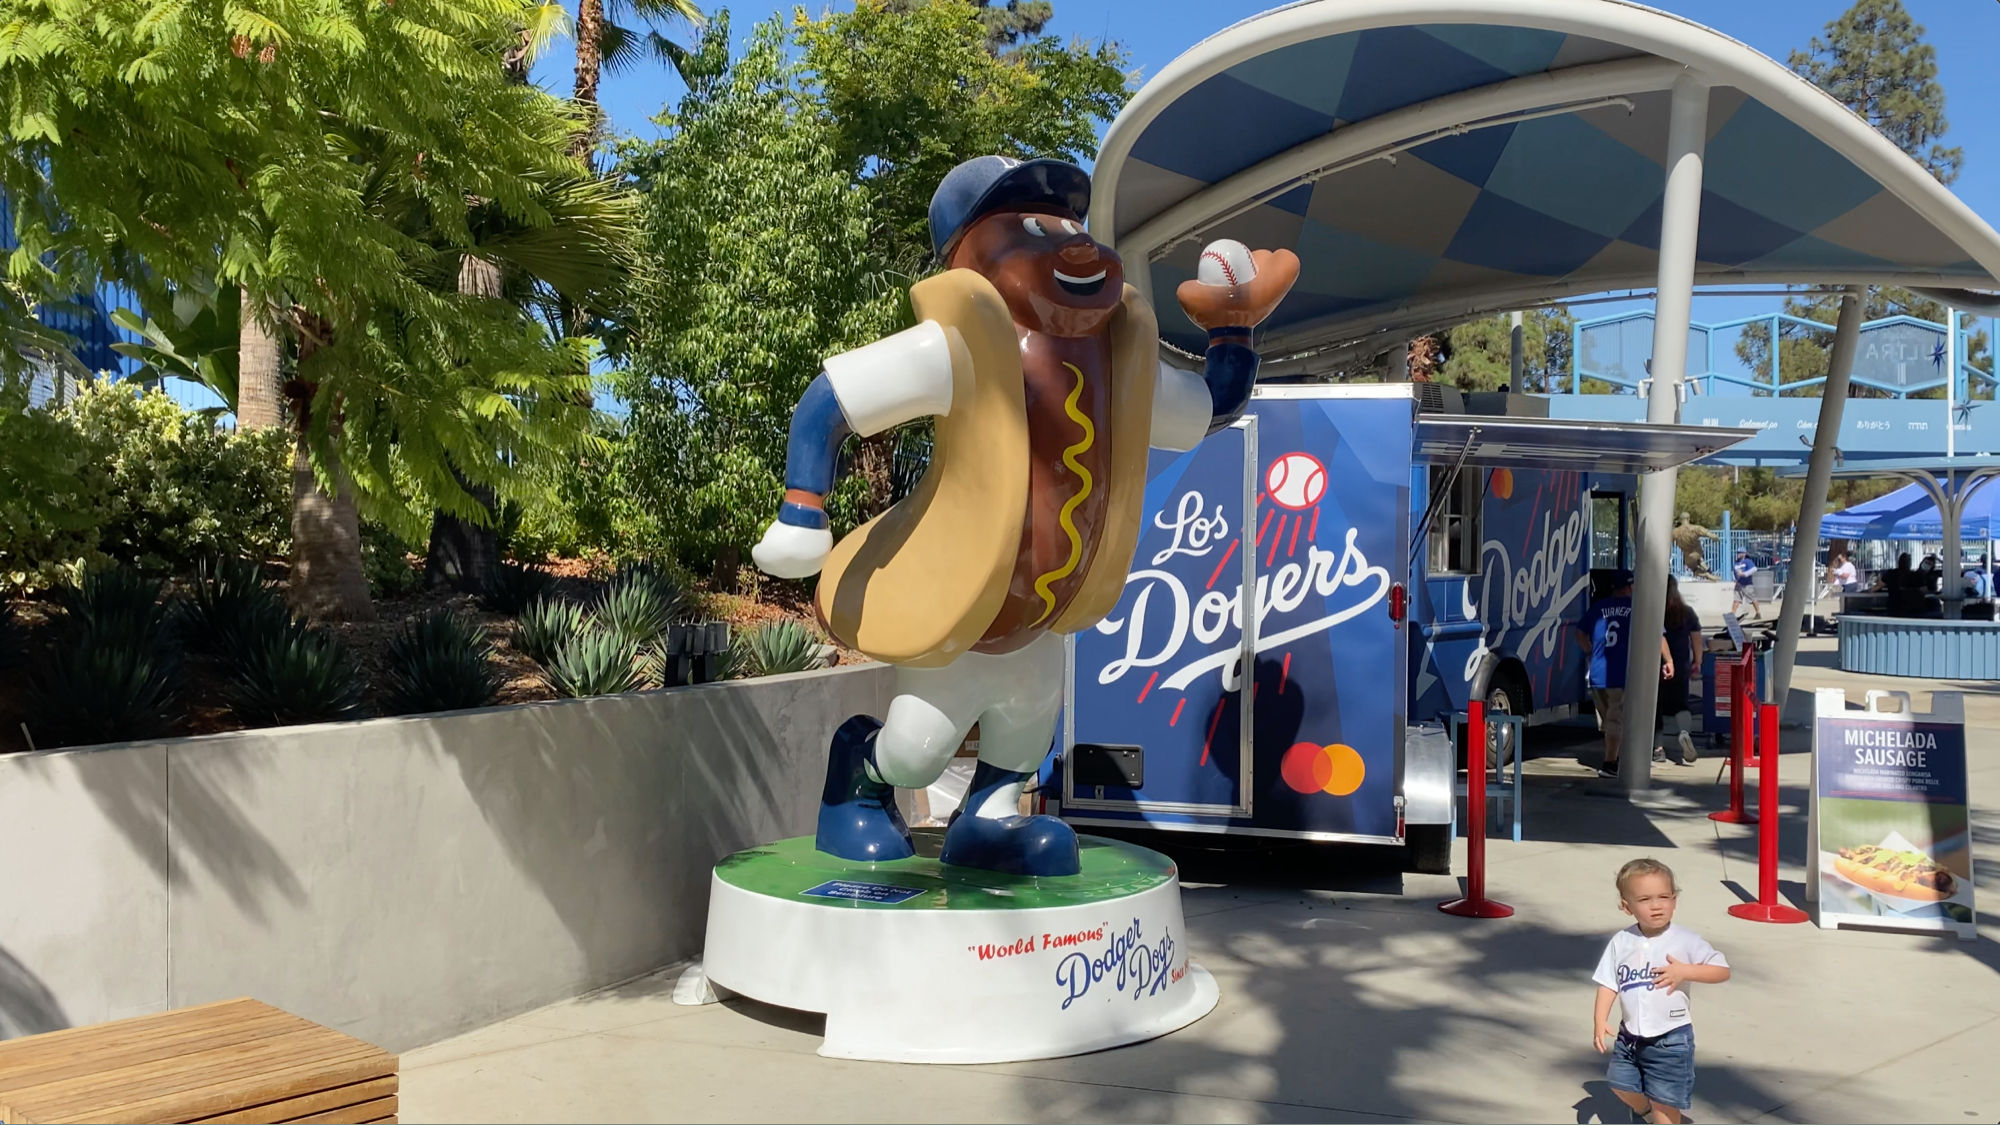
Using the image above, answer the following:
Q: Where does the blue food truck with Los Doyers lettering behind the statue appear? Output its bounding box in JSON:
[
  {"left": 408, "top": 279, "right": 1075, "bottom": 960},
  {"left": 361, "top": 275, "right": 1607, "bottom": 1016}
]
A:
[{"left": 1048, "top": 384, "right": 1744, "bottom": 871}]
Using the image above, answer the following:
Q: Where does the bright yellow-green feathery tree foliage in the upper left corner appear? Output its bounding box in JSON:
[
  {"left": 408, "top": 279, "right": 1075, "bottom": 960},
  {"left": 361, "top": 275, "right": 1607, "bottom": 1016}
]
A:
[{"left": 0, "top": 0, "right": 616, "bottom": 617}]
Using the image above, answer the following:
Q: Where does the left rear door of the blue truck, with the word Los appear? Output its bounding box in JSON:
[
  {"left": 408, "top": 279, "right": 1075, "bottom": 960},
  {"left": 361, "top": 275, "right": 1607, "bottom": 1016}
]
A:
[{"left": 1062, "top": 418, "right": 1258, "bottom": 817}]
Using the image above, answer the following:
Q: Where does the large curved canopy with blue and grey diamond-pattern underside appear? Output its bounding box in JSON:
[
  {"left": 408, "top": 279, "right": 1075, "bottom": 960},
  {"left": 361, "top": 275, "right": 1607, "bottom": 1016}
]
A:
[{"left": 1090, "top": 0, "right": 2000, "bottom": 370}]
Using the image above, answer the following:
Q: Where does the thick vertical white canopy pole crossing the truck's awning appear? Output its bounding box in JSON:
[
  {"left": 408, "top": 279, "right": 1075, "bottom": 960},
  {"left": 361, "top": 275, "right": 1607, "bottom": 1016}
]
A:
[{"left": 1618, "top": 72, "right": 1708, "bottom": 793}]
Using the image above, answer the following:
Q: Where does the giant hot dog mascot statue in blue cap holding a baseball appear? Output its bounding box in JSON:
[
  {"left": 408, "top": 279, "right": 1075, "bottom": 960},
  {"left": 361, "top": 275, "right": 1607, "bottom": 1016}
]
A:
[{"left": 752, "top": 156, "right": 1298, "bottom": 875}]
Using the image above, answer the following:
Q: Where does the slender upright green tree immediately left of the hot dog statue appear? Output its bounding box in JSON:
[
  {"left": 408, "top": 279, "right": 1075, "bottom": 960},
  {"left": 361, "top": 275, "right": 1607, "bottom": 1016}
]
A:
[{"left": 620, "top": 12, "right": 902, "bottom": 579}]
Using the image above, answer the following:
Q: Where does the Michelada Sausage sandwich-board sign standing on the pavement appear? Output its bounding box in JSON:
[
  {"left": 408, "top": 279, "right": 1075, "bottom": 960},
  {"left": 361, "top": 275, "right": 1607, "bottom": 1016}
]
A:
[{"left": 1812, "top": 691, "right": 1976, "bottom": 941}]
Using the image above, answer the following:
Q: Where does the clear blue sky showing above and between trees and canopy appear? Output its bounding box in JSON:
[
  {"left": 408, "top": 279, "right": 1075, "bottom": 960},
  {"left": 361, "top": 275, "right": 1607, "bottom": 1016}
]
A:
[{"left": 534, "top": 0, "right": 2000, "bottom": 356}]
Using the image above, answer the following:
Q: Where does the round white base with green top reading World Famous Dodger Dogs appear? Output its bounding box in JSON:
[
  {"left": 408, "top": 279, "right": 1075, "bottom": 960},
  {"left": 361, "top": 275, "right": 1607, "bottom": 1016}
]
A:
[{"left": 702, "top": 837, "right": 1216, "bottom": 1063}]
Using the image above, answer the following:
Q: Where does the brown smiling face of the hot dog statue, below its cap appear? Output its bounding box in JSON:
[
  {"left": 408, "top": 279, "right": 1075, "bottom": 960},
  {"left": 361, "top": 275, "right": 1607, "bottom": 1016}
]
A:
[{"left": 946, "top": 206, "right": 1124, "bottom": 336}]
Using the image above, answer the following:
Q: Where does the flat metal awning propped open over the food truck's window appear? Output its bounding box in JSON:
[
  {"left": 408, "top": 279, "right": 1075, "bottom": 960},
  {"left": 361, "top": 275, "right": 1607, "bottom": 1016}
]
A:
[{"left": 1416, "top": 414, "right": 1756, "bottom": 472}]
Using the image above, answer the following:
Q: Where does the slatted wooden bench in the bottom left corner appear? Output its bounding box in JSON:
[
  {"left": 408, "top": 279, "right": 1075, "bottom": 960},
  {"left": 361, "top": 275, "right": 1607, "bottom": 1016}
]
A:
[{"left": 0, "top": 999, "right": 396, "bottom": 1125}]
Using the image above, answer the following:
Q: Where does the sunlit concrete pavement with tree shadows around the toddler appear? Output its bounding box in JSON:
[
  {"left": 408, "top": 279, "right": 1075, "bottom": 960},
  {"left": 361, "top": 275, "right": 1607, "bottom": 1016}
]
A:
[{"left": 402, "top": 641, "right": 2000, "bottom": 1123}]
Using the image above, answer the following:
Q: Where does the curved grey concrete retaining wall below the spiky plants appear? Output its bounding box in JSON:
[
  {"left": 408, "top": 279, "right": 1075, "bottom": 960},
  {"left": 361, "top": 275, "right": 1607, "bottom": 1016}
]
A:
[{"left": 0, "top": 665, "right": 890, "bottom": 1051}]
